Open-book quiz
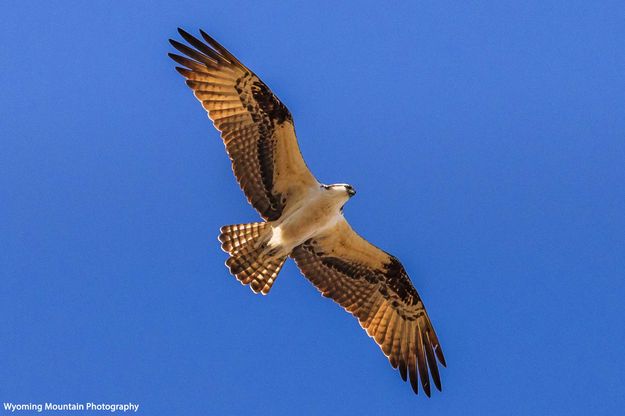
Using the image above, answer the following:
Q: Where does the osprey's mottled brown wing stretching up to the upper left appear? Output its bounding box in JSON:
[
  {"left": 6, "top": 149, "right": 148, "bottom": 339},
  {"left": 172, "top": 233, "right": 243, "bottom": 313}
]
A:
[{"left": 169, "top": 29, "right": 318, "bottom": 221}]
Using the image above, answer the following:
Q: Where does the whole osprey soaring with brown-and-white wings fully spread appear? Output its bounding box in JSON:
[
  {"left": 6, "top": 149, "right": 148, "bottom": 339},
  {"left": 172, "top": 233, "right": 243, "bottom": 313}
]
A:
[{"left": 169, "top": 29, "right": 446, "bottom": 396}]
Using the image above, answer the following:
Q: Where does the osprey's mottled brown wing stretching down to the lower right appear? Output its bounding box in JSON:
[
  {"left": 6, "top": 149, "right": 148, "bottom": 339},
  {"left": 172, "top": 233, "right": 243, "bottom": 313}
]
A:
[{"left": 291, "top": 219, "right": 446, "bottom": 396}]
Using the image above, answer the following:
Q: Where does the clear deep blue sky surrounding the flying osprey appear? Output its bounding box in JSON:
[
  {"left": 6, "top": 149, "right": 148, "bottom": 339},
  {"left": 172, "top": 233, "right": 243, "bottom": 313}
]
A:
[{"left": 0, "top": 1, "right": 625, "bottom": 416}]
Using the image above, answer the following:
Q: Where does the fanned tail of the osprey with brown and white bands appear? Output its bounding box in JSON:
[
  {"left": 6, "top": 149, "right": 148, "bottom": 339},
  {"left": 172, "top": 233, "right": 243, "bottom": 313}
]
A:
[{"left": 219, "top": 222, "right": 286, "bottom": 295}]
